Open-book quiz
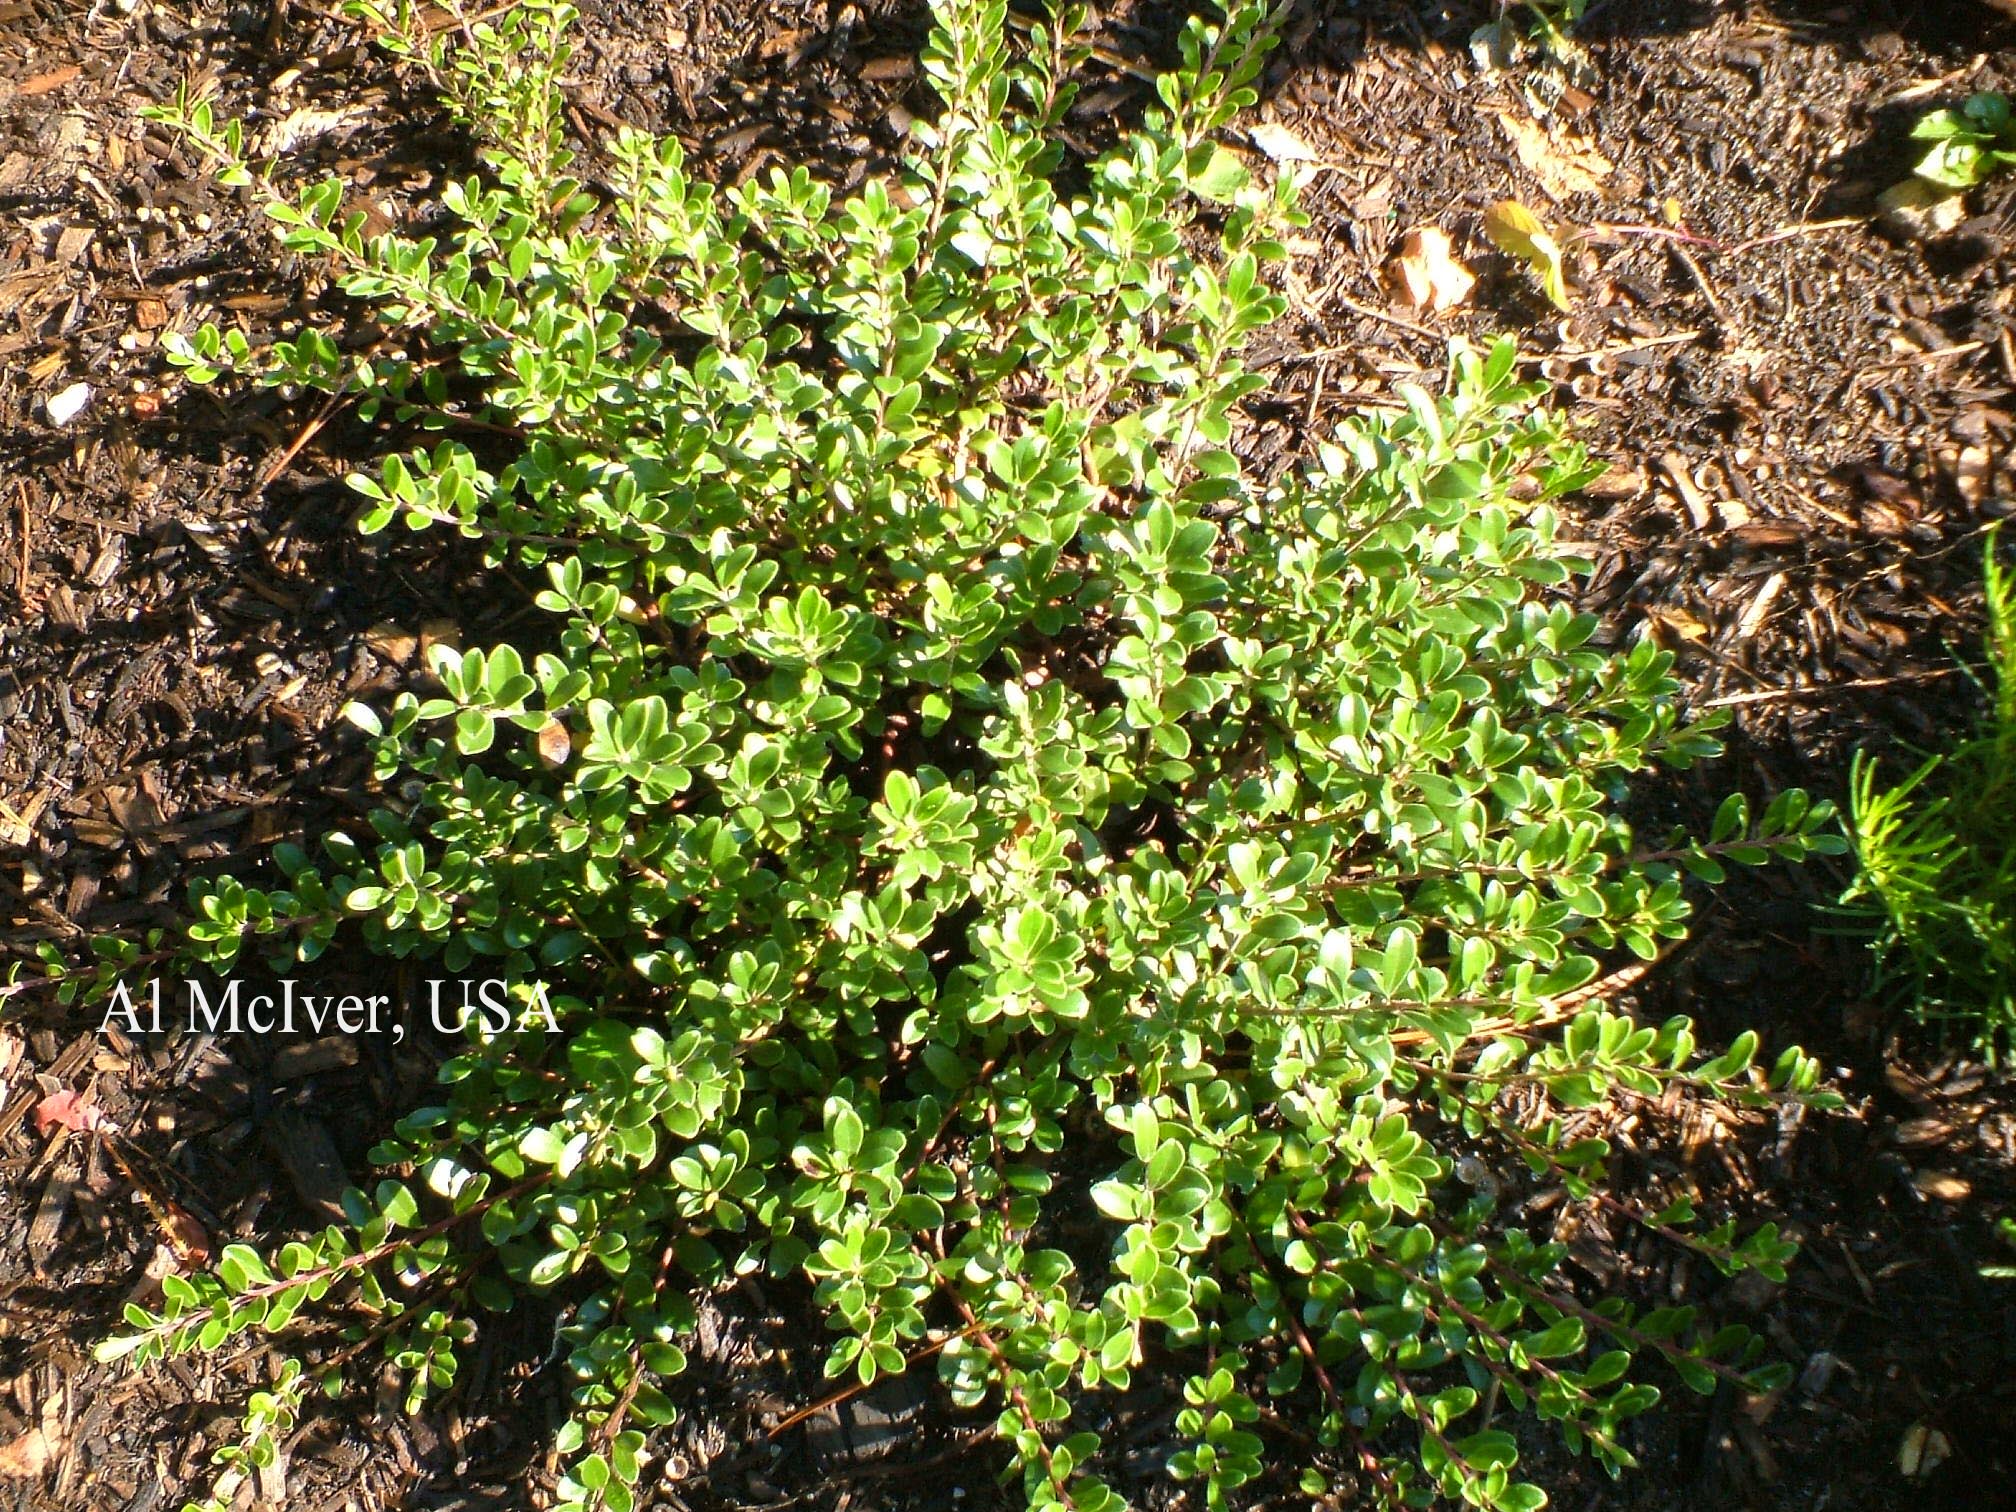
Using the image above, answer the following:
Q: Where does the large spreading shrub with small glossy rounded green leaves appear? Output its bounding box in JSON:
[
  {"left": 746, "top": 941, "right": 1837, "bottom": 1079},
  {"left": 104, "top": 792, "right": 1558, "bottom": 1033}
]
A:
[{"left": 67, "top": 0, "right": 1839, "bottom": 1512}]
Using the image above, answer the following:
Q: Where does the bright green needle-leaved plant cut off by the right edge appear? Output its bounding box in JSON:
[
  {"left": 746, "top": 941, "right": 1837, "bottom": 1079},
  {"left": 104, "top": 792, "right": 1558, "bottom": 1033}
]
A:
[{"left": 1843, "top": 530, "right": 2016, "bottom": 1056}]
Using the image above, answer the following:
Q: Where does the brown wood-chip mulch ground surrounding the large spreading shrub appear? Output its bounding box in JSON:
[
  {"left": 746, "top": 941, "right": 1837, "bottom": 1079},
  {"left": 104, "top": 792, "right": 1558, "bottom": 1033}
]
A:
[{"left": 0, "top": 0, "right": 2016, "bottom": 1512}]
